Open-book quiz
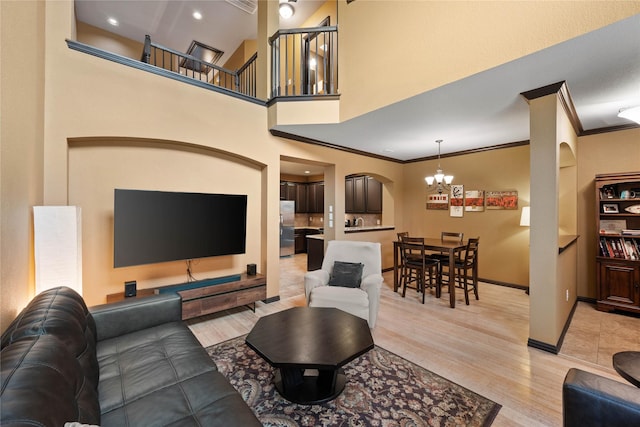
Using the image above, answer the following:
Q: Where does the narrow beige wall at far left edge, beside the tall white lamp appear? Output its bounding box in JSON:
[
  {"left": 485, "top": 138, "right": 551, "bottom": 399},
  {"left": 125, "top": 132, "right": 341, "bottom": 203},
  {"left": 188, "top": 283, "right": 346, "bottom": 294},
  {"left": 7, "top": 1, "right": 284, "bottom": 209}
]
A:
[{"left": 0, "top": 1, "right": 45, "bottom": 331}]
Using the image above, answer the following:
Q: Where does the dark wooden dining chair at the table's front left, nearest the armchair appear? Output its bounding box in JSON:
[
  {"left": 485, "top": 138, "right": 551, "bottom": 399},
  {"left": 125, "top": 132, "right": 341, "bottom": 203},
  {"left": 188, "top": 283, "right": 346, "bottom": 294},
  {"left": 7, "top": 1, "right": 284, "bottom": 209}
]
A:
[{"left": 400, "top": 236, "right": 440, "bottom": 304}]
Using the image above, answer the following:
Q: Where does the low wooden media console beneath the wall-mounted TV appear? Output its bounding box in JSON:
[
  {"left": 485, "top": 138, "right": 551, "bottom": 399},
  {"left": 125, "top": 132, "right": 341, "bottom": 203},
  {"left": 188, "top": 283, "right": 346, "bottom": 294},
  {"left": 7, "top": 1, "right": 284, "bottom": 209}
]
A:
[{"left": 107, "top": 274, "right": 267, "bottom": 320}]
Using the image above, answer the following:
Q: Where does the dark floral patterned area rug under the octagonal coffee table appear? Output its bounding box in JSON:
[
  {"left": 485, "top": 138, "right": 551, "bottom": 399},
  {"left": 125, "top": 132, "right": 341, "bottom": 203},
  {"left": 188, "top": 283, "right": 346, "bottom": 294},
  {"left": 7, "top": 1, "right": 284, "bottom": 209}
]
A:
[{"left": 207, "top": 336, "right": 501, "bottom": 427}]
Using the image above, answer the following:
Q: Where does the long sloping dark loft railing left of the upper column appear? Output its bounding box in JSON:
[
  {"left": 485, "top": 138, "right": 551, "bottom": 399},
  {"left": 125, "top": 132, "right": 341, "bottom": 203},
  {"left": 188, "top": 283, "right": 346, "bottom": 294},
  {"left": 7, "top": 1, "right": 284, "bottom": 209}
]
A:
[{"left": 140, "top": 36, "right": 258, "bottom": 98}]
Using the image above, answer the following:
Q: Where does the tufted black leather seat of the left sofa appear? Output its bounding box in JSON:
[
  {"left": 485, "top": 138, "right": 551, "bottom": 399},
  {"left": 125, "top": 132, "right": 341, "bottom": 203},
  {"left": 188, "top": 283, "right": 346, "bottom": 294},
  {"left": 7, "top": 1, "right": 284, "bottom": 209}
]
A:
[{"left": 97, "top": 322, "right": 260, "bottom": 427}]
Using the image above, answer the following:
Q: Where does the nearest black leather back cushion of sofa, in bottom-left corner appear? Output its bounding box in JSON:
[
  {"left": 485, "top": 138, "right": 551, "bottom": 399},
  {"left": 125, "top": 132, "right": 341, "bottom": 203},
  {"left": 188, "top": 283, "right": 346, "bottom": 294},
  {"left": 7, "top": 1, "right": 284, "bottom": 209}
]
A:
[{"left": 0, "top": 335, "right": 100, "bottom": 426}]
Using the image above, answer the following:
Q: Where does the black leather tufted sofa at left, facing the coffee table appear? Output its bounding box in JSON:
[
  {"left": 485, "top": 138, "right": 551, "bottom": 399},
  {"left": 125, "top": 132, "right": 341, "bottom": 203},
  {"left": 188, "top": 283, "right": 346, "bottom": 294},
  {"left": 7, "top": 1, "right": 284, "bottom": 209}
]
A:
[{"left": 0, "top": 287, "right": 261, "bottom": 427}]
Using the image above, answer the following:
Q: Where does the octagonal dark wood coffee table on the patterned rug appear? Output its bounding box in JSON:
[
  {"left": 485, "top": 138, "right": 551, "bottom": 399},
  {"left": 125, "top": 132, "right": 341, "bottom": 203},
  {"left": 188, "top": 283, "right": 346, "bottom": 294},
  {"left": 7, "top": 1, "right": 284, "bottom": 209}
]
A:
[{"left": 245, "top": 307, "right": 373, "bottom": 405}]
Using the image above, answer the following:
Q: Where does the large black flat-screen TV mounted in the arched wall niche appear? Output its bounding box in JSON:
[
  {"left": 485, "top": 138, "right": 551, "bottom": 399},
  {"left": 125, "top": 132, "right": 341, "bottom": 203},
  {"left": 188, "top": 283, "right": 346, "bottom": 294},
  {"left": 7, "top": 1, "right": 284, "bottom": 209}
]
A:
[{"left": 113, "top": 189, "right": 247, "bottom": 267}]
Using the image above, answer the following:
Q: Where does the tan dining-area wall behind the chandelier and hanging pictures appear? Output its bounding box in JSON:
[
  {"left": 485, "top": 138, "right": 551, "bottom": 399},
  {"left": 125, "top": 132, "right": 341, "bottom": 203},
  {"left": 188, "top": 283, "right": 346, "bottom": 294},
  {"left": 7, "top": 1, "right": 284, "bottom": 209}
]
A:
[{"left": 398, "top": 145, "right": 529, "bottom": 286}]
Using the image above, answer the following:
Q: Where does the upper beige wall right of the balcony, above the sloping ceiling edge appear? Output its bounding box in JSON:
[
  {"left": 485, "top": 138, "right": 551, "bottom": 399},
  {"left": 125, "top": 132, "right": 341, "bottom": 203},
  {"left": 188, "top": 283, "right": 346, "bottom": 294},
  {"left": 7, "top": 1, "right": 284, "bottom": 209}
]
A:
[{"left": 338, "top": 0, "right": 640, "bottom": 121}]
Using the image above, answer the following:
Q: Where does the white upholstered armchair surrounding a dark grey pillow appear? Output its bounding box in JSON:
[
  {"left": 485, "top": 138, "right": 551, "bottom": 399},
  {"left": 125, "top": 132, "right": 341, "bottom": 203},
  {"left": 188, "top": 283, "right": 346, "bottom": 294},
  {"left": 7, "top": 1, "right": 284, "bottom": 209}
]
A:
[{"left": 304, "top": 240, "right": 383, "bottom": 328}]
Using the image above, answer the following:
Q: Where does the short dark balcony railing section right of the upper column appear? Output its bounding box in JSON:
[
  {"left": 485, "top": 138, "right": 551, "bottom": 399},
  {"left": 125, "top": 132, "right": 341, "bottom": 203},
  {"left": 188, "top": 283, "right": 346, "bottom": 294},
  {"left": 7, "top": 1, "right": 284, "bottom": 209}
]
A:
[{"left": 269, "top": 26, "right": 338, "bottom": 98}]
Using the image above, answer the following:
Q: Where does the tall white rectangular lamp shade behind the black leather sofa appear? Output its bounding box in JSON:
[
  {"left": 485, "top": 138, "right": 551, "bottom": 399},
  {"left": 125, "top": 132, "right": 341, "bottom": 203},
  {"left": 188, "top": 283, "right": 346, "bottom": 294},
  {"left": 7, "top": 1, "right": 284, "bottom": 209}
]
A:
[{"left": 33, "top": 206, "right": 82, "bottom": 295}]
